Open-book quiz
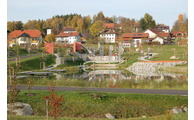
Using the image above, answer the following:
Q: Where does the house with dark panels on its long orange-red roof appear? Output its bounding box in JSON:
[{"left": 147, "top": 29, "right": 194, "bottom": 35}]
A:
[{"left": 117, "top": 33, "right": 149, "bottom": 47}]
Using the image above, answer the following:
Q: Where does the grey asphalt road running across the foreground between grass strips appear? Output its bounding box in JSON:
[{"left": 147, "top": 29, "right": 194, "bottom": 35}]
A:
[{"left": 9, "top": 86, "right": 188, "bottom": 96}]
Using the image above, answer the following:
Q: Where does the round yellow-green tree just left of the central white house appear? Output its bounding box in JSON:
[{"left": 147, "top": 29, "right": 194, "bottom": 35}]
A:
[{"left": 90, "top": 21, "right": 104, "bottom": 37}]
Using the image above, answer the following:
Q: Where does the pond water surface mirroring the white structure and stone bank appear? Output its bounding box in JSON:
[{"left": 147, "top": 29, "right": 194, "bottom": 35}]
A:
[{"left": 54, "top": 70, "right": 188, "bottom": 82}]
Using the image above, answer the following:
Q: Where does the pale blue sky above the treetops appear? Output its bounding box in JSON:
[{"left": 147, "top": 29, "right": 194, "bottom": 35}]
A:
[{"left": 7, "top": 0, "right": 188, "bottom": 29}]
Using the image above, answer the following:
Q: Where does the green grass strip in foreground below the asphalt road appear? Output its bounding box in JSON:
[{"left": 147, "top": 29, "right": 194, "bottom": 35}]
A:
[{"left": 8, "top": 89, "right": 188, "bottom": 120}]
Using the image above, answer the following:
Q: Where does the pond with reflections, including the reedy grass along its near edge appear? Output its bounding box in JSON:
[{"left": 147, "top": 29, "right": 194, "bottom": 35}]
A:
[{"left": 14, "top": 70, "right": 188, "bottom": 90}]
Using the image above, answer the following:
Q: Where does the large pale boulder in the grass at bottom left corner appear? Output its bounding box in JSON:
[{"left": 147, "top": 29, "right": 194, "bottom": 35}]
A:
[{"left": 7, "top": 102, "right": 34, "bottom": 115}]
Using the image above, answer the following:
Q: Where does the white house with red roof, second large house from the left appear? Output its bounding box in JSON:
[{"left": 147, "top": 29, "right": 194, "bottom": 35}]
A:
[{"left": 55, "top": 27, "right": 82, "bottom": 44}]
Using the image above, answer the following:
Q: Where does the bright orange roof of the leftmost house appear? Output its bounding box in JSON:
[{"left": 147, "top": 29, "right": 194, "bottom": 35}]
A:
[{"left": 8, "top": 30, "right": 41, "bottom": 38}]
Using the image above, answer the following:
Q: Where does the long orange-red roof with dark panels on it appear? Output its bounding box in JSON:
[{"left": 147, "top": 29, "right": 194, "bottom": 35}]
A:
[{"left": 122, "top": 33, "right": 149, "bottom": 38}]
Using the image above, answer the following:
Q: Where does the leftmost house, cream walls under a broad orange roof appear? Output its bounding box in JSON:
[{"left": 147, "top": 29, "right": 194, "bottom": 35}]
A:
[{"left": 8, "top": 30, "right": 42, "bottom": 47}]
